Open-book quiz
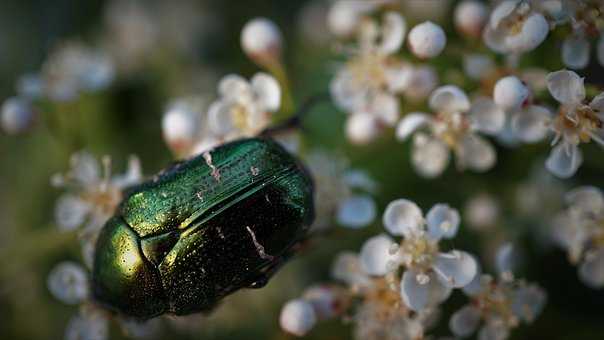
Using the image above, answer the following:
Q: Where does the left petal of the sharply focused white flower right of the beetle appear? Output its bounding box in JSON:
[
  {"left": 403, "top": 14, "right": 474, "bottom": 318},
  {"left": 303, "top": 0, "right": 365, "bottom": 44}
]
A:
[{"left": 359, "top": 234, "right": 396, "bottom": 276}]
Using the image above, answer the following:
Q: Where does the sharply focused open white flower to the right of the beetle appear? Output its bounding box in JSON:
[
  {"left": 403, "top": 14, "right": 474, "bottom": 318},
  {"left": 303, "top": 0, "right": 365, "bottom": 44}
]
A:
[{"left": 377, "top": 199, "right": 477, "bottom": 311}]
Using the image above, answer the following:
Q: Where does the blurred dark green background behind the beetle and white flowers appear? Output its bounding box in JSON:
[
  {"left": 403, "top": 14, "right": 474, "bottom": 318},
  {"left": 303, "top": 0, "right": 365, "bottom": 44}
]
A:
[{"left": 0, "top": 0, "right": 604, "bottom": 340}]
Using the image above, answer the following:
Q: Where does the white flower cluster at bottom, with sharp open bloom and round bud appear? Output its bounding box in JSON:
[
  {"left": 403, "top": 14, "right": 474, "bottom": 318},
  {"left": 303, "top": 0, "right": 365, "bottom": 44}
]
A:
[{"left": 280, "top": 199, "right": 477, "bottom": 339}]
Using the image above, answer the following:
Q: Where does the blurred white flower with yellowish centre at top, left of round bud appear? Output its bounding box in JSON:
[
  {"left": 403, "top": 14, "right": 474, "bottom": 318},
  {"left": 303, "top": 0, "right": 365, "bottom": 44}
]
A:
[{"left": 330, "top": 12, "right": 410, "bottom": 143}]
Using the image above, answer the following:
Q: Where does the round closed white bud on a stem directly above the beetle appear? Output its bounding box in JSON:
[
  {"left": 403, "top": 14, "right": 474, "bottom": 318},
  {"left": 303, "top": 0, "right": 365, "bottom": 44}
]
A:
[{"left": 241, "top": 18, "right": 283, "bottom": 65}]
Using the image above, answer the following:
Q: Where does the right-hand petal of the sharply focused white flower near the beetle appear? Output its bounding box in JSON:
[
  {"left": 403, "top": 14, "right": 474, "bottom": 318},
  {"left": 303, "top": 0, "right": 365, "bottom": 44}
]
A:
[{"left": 433, "top": 250, "right": 478, "bottom": 288}]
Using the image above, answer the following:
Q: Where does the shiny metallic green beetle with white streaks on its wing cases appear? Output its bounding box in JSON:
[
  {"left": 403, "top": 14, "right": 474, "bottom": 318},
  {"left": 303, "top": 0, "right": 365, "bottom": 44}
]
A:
[{"left": 92, "top": 138, "right": 314, "bottom": 319}]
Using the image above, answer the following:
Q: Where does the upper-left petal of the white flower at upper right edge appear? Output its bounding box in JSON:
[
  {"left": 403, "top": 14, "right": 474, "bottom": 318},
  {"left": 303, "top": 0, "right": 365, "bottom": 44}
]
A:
[{"left": 546, "top": 70, "right": 585, "bottom": 104}]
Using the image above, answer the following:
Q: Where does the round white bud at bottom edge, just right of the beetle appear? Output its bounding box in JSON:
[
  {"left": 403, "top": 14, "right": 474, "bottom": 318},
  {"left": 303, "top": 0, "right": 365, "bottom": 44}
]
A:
[{"left": 279, "top": 299, "right": 317, "bottom": 336}]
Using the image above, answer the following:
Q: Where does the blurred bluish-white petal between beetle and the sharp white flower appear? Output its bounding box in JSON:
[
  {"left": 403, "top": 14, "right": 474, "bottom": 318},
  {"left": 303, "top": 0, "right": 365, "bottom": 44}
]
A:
[{"left": 337, "top": 195, "right": 377, "bottom": 229}]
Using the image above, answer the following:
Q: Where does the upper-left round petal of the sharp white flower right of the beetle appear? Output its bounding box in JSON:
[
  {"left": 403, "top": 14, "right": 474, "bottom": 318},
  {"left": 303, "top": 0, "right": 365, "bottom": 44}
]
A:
[{"left": 383, "top": 198, "right": 424, "bottom": 236}]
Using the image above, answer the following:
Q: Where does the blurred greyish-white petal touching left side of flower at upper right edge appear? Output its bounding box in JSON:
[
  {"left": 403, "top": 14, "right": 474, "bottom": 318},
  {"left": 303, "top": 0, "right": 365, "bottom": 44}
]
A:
[{"left": 511, "top": 105, "right": 551, "bottom": 143}]
